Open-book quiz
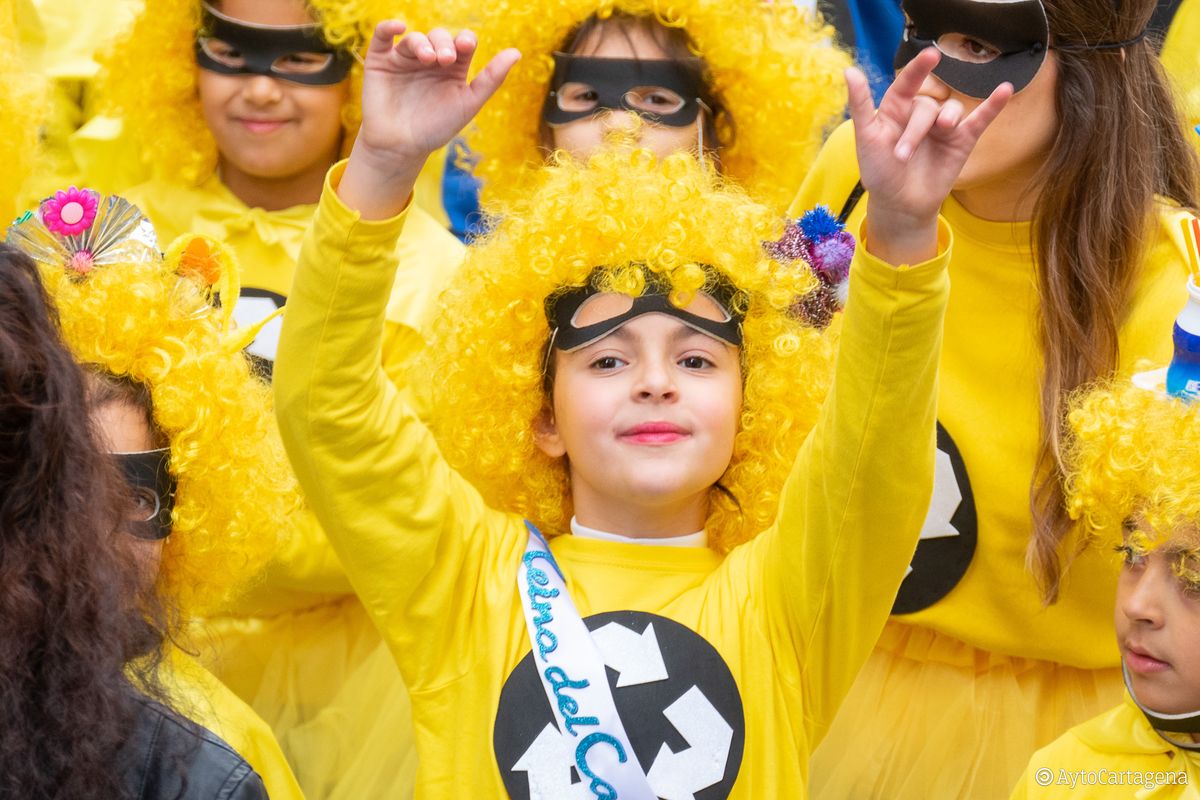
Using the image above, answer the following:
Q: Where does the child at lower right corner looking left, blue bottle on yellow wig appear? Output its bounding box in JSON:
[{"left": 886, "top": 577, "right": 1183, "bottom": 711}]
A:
[{"left": 1013, "top": 384, "right": 1200, "bottom": 800}]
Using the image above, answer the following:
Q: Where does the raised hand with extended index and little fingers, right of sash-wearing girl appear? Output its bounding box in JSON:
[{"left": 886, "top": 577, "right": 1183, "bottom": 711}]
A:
[{"left": 846, "top": 48, "right": 1013, "bottom": 264}]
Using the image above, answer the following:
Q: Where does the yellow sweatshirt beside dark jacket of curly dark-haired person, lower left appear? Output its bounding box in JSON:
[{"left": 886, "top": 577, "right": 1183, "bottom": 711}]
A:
[{"left": 161, "top": 645, "right": 304, "bottom": 800}]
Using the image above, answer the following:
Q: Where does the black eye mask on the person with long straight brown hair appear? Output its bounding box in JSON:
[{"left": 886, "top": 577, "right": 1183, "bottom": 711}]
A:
[{"left": 895, "top": 0, "right": 1050, "bottom": 100}]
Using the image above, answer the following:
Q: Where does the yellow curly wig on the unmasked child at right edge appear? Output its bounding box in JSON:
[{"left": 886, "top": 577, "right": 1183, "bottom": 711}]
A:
[{"left": 1066, "top": 383, "right": 1200, "bottom": 584}]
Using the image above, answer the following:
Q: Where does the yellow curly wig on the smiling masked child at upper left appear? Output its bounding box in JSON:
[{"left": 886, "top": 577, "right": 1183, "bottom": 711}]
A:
[{"left": 98, "top": 0, "right": 412, "bottom": 185}]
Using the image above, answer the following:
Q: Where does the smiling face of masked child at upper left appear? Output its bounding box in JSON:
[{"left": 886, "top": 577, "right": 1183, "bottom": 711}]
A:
[{"left": 197, "top": 0, "right": 349, "bottom": 199}]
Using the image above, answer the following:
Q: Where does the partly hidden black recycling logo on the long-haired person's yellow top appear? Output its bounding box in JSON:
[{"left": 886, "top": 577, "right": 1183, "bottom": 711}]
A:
[{"left": 892, "top": 422, "right": 979, "bottom": 614}]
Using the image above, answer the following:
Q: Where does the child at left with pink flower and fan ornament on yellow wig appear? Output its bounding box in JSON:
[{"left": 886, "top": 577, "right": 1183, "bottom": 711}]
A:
[{"left": 8, "top": 188, "right": 302, "bottom": 798}]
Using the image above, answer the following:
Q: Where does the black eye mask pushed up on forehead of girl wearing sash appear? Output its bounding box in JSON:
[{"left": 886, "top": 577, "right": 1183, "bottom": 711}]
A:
[{"left": 546, "top": 270, "right": 742, "bottom": 353}]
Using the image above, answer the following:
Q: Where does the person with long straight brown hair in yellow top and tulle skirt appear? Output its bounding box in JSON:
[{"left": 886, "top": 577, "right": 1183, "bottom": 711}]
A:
[{"left": 793, "top": 0, "right": 1198, "bottom": 800}]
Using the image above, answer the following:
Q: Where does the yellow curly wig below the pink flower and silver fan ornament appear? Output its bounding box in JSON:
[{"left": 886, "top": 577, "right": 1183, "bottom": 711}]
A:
[{"left": 33, "top": 219, "right": 298, "bottom": 615}]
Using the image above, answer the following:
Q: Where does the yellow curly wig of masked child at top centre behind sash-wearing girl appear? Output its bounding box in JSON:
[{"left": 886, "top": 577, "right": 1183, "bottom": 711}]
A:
[{"left": 444, "top": 0, "right": 851, "bottom": 214}]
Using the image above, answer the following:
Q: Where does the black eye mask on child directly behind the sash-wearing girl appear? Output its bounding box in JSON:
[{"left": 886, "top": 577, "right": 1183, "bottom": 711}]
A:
[{"left": 541, "top": 53, "right": 702, "bottom": 128}]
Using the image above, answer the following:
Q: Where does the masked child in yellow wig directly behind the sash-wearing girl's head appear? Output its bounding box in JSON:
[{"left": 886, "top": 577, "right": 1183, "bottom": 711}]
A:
[{"left": 446, "top": 0, "right": 850, "bottom": 210}]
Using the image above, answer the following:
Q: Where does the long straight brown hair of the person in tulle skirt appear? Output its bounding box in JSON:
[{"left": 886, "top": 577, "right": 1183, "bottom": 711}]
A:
[{"left": 1026, "top": 0, "right": 1198, "bottom": 602}]
